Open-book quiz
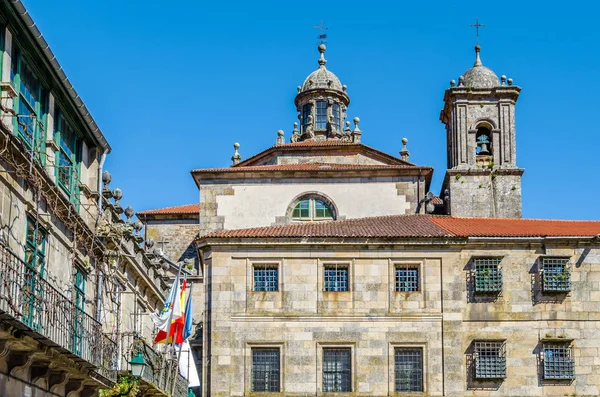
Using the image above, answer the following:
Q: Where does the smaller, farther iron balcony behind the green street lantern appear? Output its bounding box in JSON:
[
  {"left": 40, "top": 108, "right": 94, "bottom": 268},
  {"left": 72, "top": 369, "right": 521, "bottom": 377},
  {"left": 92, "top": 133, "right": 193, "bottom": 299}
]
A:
[{"left": 121, "top": 334, "right": 188, "bottom": 397}]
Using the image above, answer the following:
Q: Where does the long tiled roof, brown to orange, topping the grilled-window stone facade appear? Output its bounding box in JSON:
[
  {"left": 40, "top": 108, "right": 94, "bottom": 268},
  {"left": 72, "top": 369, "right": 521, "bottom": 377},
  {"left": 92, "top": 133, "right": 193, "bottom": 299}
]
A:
[{"left": 204, "top": 215, "right": 600, "bottom": 238}]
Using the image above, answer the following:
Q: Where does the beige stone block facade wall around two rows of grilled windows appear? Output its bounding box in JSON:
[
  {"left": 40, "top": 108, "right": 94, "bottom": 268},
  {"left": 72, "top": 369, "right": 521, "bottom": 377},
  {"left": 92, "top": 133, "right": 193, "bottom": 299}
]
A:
[{"left": 202, "top": 239, "right": 600, "bottom": 396}]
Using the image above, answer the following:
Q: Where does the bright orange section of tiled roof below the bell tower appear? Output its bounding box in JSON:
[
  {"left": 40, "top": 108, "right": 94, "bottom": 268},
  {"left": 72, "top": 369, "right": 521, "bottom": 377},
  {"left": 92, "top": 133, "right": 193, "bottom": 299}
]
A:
[{"left": 431, "top": 216, "right": 600, "bottom": 237}]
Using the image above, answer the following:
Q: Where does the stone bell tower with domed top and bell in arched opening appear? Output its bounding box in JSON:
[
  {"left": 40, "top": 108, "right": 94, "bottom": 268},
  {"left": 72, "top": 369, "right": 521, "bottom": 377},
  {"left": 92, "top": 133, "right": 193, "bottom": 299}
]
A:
[{"left": 440, "top": 45, "right": 525, "bottom": 218}]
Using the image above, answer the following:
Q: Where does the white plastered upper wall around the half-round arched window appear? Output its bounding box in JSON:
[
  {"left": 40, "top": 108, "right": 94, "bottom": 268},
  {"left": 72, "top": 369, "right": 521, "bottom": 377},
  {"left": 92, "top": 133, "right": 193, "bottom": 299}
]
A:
[{"left": 200, "top": 176, "right": 425, "bottom": 234}]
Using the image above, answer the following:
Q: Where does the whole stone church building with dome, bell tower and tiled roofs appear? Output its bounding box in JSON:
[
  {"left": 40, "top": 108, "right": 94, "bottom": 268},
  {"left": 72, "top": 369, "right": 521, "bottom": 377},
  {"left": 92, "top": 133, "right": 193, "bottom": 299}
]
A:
[{"left": 138, "top": 44, "right": 600, "bottom": 397}]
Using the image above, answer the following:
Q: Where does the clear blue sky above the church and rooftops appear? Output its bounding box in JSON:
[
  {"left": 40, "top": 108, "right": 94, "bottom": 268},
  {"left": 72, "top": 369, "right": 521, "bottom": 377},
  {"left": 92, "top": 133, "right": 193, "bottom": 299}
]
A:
[{"left": 24, "top": 0, "right": 600, "bottom": 219}]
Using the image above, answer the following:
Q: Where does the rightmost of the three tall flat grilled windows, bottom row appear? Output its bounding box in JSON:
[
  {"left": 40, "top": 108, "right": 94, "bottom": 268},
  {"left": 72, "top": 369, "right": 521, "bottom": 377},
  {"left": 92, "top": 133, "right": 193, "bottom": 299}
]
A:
[{"left": 394, "top": 347, "right": 423, "bottom": 392}]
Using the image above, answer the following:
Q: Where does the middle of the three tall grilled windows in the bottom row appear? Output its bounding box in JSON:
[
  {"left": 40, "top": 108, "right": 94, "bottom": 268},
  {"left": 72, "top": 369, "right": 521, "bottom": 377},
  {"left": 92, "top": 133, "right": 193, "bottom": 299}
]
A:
[{"left": 323, "top": 348, "right": 352, "bottom": 392}]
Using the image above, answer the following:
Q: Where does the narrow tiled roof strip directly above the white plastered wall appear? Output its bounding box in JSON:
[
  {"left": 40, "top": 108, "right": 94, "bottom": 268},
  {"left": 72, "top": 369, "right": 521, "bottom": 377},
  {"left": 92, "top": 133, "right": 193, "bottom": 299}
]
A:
[{"left": 192, "top": 163, "right": 422, "bottom": 173}]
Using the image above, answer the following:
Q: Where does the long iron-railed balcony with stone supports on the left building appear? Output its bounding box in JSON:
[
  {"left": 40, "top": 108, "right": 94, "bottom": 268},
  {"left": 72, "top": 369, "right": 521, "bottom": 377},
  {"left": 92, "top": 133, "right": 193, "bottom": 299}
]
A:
[{"left": 0, "top": 240, "right": 117, "bottom": 388}]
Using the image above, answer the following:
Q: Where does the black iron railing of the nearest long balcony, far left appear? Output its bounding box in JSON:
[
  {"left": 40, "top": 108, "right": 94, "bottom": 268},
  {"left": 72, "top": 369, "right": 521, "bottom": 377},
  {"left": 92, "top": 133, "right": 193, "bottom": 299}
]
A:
[{"left": 0, "top": 244, "right": 117, "bottom": 381}]
